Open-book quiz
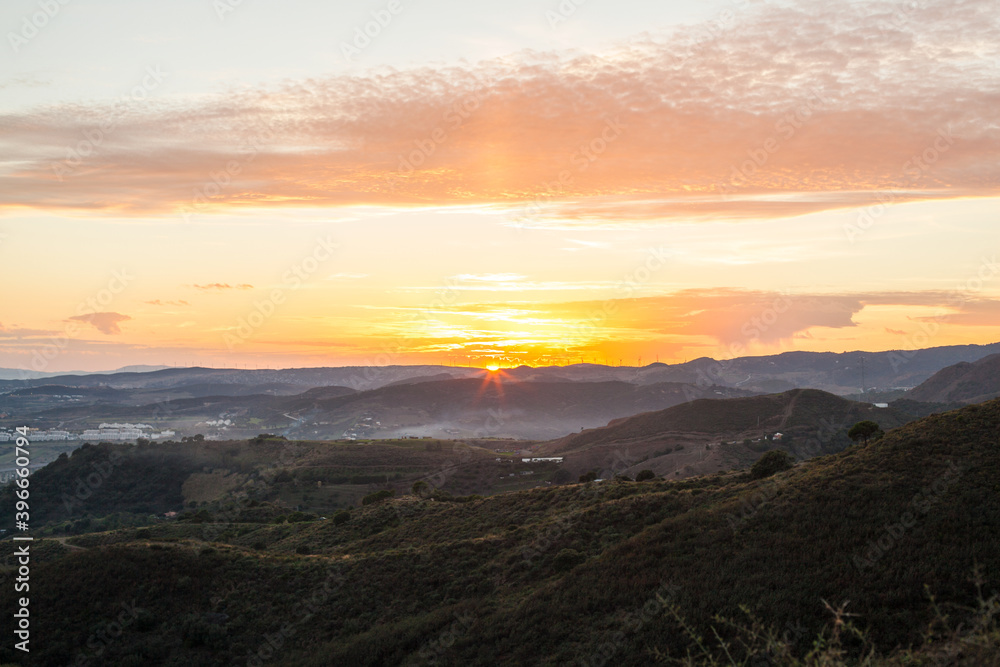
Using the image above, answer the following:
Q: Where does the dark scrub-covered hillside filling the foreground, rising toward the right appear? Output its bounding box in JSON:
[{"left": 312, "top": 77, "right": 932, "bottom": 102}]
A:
[{"left": 0, "top": 401, "right": 1000, "bottom": 665}]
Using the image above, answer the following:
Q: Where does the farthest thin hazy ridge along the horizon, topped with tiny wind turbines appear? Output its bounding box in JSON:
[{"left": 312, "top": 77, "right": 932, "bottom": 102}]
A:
[{"left": 0, "top": 343, "right": 1000, "bottom": 395}]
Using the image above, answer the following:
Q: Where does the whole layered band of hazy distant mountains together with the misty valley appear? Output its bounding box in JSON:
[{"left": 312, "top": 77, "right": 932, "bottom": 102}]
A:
[{"left": 0, "top": 343, "right": 1000, "bottom": 441}]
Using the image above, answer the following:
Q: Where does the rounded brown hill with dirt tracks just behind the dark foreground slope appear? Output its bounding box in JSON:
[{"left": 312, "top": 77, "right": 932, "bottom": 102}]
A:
[{"left": 534, "top": 389, "right": 913, "bottom": 478}]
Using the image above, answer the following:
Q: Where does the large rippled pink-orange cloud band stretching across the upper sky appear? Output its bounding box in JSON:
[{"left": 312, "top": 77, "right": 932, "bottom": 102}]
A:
[{"left": 0, "top": 0, "right": 1000, "bottom": 224}]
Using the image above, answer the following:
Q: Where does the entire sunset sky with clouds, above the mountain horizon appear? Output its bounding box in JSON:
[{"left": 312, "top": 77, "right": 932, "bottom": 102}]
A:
[{"left": 0, "top": 0, "right": 1000, "bottom": 372}]
